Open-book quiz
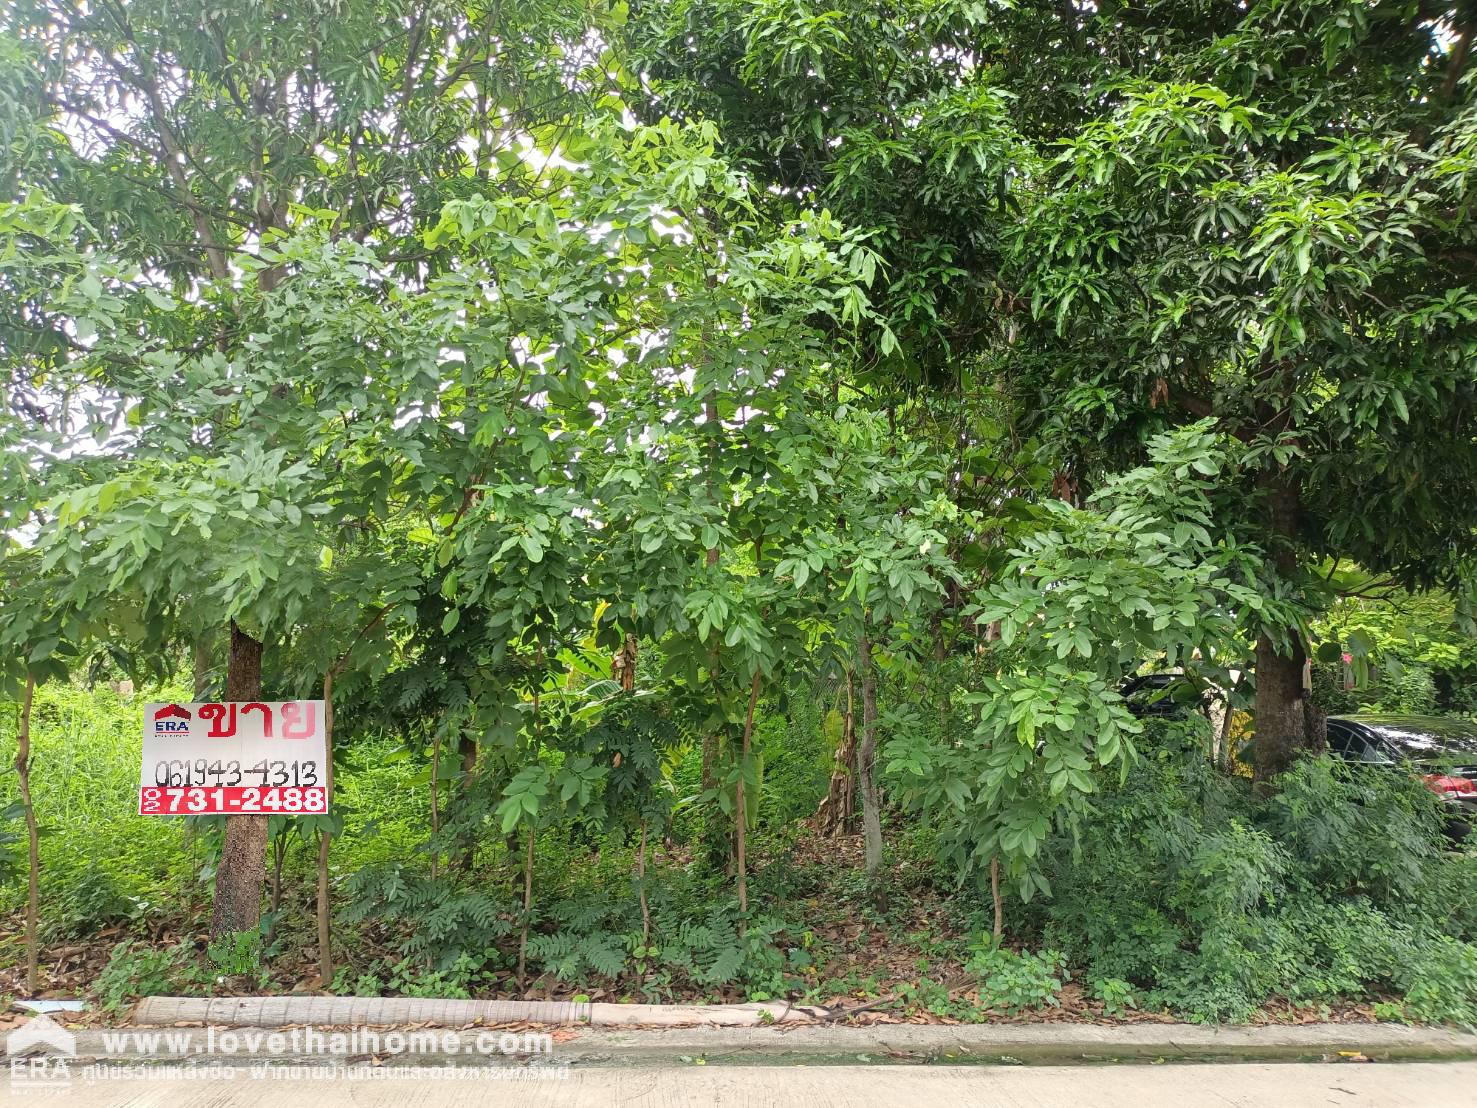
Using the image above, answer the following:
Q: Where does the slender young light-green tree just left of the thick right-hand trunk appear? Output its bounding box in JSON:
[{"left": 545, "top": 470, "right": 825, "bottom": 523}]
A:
[{"left": 889, "top": 424, "right": 1263, "bottom": 938}]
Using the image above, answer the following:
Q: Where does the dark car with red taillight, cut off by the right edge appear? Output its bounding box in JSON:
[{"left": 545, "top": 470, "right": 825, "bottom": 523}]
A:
[{"left": 1328, "top": 714, "right": 1477, "bottom": 842}]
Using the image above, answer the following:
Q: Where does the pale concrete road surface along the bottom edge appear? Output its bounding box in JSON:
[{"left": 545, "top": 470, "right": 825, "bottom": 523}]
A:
[{"left": 0, "top": 1062, "right": 1477, "bottom": 1108}]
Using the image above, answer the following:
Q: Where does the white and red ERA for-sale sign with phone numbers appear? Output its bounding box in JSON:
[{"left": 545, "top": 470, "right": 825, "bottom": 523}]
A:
[{"left": 139, "top": 700, "right": 328, "bottom": 815}]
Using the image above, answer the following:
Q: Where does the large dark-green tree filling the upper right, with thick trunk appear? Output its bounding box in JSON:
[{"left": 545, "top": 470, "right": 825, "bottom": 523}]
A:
[{"left": 632, "top": 0, "right": 1474, "bottom": 777}]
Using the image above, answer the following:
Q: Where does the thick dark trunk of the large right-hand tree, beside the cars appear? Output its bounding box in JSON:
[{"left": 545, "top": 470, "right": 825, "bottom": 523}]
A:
[{"left": 1254, "top": 470, "right": 1319, "bottom": 787}]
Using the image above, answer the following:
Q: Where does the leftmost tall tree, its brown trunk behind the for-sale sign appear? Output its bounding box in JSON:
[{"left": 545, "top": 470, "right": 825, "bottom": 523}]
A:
[{"left": 4, "top": 3, "right": 611, "bottom": 932}]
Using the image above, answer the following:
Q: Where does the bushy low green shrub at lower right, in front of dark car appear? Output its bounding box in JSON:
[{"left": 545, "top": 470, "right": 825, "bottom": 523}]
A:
[{"left": 1034, "top": 750, "right": 1459, "bottom": 1022}]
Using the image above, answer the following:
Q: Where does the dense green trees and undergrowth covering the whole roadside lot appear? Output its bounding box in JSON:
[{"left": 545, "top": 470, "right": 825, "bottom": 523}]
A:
[{"left": 0, "top": 0, "right": 1477, "bottom": 1022}]
